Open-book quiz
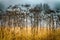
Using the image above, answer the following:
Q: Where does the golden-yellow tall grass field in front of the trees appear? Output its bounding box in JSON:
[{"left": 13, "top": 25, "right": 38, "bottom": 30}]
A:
[{"left": 0, "top": 27, "right": 60, "bottom": 40}]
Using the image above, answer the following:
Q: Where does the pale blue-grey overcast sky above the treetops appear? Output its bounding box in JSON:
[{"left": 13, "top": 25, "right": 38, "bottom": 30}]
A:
[{"left": 0, "top": 0, "right": 60, "bottom": 7}]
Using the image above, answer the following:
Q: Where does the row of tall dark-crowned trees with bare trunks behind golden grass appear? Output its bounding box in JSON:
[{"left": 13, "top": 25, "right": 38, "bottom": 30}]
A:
[{"left": 0, "top": 3, "right": 60, "bottom": 29}]
